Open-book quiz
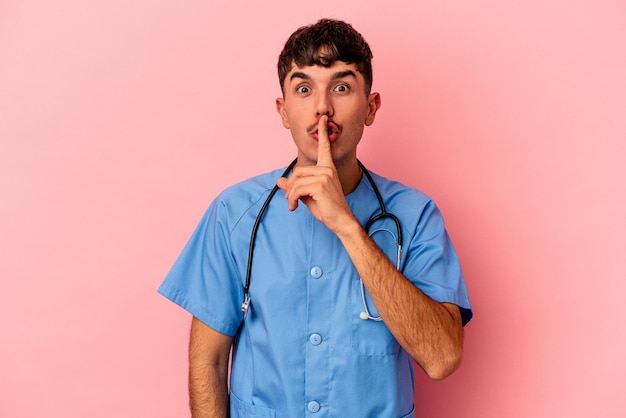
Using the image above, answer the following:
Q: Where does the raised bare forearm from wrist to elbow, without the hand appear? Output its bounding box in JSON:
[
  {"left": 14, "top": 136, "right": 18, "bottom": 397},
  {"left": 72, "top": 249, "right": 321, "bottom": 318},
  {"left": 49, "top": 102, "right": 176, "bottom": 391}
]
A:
[{"left": 338, "top": 223, "right": 463, "bottom": 379}]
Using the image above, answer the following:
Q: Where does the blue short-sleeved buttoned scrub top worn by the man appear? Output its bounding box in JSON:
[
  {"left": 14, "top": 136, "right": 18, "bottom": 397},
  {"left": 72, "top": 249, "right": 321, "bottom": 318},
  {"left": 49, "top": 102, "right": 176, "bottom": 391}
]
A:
[{"left": 159, "top": 170, "right": 472, "bottom": 418}]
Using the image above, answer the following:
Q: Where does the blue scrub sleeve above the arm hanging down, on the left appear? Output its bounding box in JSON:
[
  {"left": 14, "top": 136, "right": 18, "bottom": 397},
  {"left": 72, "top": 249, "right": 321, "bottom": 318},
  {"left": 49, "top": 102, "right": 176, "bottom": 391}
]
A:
[{"left": 158, "top": 200, "right": 243, "bottom": 336}]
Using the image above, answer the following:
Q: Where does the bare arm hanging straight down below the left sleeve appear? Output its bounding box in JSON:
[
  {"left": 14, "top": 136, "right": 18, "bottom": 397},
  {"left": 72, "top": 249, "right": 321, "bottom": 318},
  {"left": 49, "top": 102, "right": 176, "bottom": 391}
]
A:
[{"left": 189, "top": 317, "right": 233, "bottom": 418}]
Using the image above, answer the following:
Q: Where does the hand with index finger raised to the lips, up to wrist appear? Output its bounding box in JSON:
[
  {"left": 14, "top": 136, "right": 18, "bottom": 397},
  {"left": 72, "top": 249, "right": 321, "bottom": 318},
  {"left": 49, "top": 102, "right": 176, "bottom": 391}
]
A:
[{"left": 276, "top": 115, "right": 354, "bottom": 233}]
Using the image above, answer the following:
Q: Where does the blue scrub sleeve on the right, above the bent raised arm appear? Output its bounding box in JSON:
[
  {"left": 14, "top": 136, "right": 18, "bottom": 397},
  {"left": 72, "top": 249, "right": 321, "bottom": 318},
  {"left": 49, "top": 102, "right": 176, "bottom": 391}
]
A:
[{"left": 402, "top": 200, "right": 472, "bottom": 325}]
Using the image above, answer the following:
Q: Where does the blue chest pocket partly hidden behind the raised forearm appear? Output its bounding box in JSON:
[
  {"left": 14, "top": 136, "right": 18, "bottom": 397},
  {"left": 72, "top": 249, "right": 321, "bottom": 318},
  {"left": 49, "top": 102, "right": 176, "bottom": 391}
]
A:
[{"left": 350, "top": 280, "right": 400, "bottom": 356}]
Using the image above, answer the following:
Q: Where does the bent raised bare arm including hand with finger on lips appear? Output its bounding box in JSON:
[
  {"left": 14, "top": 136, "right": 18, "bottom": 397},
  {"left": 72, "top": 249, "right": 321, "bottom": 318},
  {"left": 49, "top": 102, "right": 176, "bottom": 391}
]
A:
[{"left": 278, "top": 116, "right": 463, "bottom": 379}]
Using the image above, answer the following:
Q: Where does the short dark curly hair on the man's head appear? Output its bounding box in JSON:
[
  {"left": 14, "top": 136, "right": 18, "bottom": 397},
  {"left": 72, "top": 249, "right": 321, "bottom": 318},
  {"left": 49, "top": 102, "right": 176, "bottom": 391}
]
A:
[{"left": 278, "top": 19, "right": 373, "bottom": 94}]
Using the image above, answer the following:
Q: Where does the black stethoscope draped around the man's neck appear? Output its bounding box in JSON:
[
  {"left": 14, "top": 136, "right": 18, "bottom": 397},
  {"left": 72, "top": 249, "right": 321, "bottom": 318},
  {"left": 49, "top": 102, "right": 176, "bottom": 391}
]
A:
[{"left": 241, "top": 158, "right": 402, "bottom": 321}]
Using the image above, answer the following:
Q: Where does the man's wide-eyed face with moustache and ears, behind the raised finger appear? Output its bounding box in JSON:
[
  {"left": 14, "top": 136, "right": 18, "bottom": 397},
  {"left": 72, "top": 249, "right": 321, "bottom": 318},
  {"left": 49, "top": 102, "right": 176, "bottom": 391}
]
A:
[{"left": 276, "top": 61, "right": 380, "bottom": 165}]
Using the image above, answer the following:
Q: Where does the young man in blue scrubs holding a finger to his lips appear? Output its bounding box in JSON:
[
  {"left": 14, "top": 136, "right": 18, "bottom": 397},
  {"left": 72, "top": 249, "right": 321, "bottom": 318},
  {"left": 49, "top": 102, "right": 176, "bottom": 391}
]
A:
[{"left": 159, "top": 20, "right": 472, "bottom": 418}]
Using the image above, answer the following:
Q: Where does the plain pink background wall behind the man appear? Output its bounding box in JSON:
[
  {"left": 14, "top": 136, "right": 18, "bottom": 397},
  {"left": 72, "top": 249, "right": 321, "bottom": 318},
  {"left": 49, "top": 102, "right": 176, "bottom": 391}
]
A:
[{"left": 0, "top": 0, "right": 626, "bottom": 418}]
